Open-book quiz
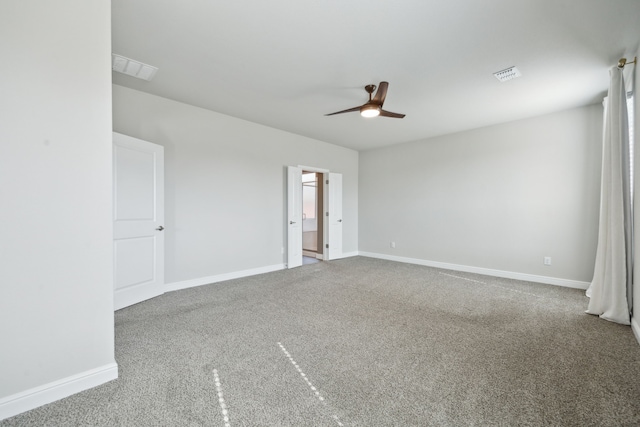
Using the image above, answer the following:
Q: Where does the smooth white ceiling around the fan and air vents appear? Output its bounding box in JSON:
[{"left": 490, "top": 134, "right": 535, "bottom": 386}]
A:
[{"left": 112, "top": 0, "right": 640, "bottom": 150}]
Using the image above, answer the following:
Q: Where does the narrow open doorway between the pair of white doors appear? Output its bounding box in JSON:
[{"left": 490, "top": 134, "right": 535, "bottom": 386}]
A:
[{"left": 302, "top": 171, "right": 324, "bottom": 264}]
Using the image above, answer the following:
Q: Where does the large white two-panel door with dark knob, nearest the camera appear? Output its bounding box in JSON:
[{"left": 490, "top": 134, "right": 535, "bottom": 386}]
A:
[{"left": 113, "top": 133, "right": 164, "bottom": 310}]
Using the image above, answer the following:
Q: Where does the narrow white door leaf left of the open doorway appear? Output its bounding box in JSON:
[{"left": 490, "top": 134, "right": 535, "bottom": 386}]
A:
[{"left": 287, "top": 166, "right": 302, "bottom": 268}]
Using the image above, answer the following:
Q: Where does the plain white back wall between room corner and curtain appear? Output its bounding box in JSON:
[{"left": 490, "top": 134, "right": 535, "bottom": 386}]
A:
[{"left": 359, "top": 105, "right": 602, "bottom": 282}]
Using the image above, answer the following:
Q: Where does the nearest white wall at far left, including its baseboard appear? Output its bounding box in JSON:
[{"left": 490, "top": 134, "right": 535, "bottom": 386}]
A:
[{"left": 0, "top": 0, "right": 117, "bottom": 418}]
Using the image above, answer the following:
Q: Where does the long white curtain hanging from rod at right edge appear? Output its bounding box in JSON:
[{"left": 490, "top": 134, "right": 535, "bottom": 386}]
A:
[{"left": 587, "top": 67, "right": 633, "bottom": 325}]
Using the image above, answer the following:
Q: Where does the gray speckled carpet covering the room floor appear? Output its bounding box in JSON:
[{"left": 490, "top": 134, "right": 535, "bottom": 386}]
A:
[{"left": 0, "top": 257, "right": 640, "bottom": 427}]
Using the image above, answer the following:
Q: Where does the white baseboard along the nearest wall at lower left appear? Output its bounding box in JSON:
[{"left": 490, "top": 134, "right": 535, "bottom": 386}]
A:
[{"left": 0, "top": 362, "right": 118, "bottom": 420}]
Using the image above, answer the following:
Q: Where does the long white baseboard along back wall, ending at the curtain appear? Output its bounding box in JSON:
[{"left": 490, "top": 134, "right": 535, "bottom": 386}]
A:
[{"left": 359, "top": 252, "right": 589, "bottom": 290}]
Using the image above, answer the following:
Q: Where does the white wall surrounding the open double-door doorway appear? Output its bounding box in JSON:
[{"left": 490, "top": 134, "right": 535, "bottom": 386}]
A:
[{"left": 113, "top": 85, "right": 358, "bottom": 283}]
